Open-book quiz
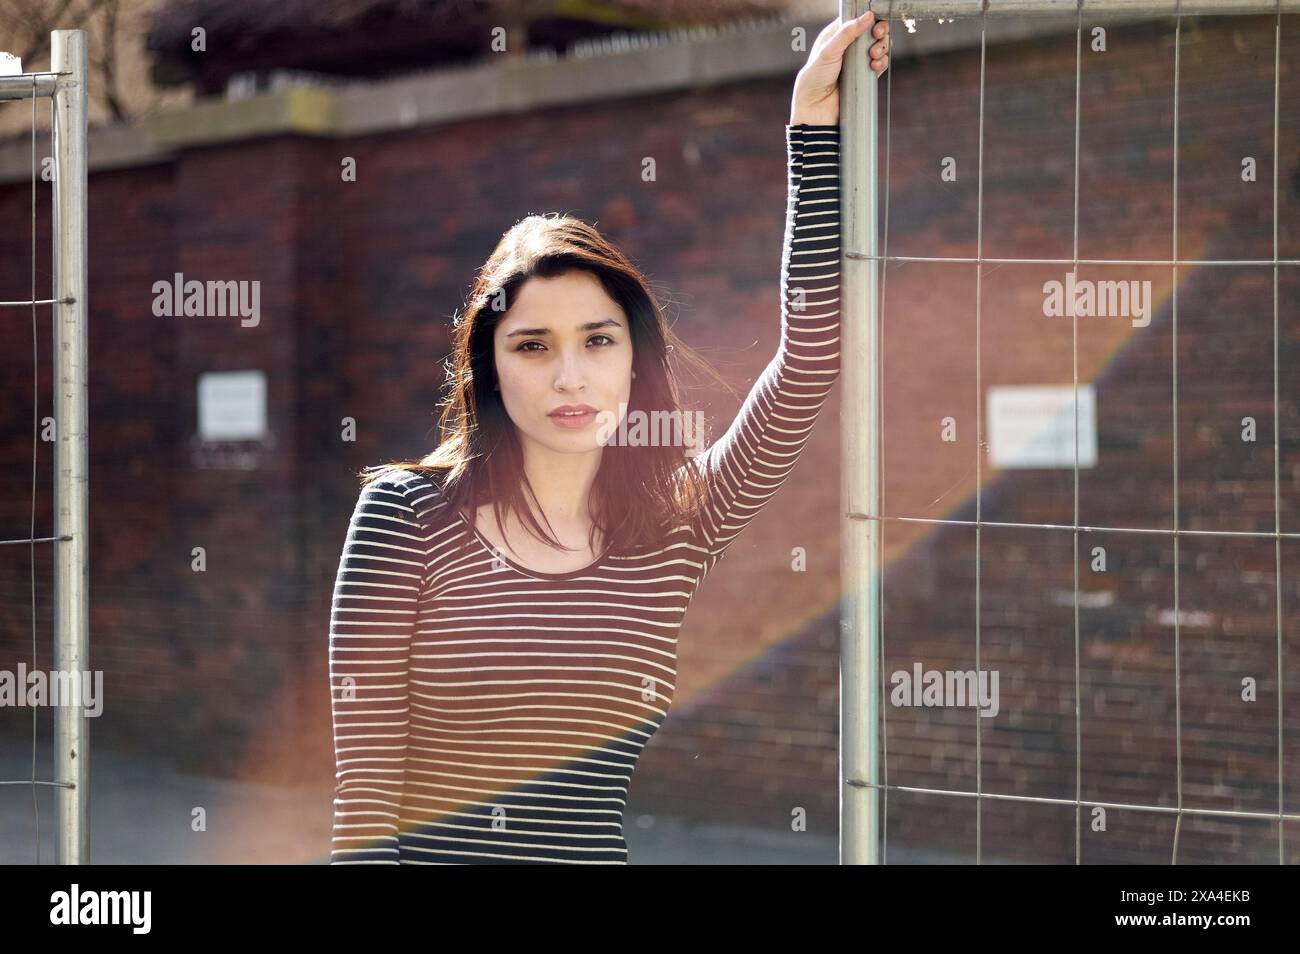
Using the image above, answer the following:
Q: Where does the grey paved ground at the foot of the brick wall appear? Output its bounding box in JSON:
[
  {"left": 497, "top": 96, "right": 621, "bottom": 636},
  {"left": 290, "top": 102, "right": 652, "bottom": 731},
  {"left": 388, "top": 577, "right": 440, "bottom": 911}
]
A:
[{"left": 0, "top": 742, "right": 987, "bottom": 864}]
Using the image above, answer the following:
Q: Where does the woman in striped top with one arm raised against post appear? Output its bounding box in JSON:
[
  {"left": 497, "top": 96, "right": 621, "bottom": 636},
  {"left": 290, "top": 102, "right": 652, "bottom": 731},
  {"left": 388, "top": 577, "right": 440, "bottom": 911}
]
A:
[{"left": 330, "top": 13, "right": 889, "bottom": 864}]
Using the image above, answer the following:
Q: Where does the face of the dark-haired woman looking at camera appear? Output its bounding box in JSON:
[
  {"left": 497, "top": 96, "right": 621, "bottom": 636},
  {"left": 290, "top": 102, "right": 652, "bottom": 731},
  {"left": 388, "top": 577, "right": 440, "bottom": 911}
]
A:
[{"left": 493, "top": 270, "right": 632, "bottom": 454}]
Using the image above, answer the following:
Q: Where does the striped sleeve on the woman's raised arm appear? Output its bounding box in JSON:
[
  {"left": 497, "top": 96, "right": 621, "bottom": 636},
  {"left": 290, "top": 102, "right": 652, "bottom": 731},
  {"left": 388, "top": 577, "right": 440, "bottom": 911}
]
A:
[{"left": 694, "top": 123, "right": 840, "bottom": 569}]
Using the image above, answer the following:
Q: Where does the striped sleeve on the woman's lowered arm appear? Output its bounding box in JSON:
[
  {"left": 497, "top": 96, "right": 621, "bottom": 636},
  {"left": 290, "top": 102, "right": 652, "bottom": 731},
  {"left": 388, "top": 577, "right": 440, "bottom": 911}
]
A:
[{"left": 329, "top": 472, "right": 425, "bottom": 864}]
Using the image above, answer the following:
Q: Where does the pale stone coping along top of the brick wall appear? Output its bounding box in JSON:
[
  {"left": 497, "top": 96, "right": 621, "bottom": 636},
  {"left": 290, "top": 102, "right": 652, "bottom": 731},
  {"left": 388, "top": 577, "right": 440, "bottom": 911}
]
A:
[{"left": 0, "top": 16, "right": 1149, "bottom": 182}]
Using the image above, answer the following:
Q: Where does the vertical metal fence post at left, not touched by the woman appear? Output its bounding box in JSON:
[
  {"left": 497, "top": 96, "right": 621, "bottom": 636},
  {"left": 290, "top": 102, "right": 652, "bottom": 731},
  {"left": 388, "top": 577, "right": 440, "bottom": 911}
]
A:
[{"left": 49, "top": 30, "right": 90, "bottom": 864}]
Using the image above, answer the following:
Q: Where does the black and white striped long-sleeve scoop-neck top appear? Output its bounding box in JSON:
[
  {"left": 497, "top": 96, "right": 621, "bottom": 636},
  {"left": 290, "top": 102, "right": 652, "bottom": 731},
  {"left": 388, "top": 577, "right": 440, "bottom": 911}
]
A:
[{"left": 329, "top": 123, "right": 840, "bottom": 864}]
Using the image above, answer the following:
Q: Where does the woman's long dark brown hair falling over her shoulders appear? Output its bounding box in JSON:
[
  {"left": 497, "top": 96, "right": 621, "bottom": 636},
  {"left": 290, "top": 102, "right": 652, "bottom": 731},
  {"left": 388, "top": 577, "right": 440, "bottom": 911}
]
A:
[{"left": 358, "top": 213, "right": 735, "bottom": 550}]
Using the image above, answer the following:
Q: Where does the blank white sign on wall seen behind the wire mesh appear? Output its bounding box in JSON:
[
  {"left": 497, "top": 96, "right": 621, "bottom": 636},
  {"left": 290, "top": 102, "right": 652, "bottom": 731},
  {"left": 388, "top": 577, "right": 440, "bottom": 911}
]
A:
[{"left": 988, "top": 383, "right": 1097, "bottom": 468}]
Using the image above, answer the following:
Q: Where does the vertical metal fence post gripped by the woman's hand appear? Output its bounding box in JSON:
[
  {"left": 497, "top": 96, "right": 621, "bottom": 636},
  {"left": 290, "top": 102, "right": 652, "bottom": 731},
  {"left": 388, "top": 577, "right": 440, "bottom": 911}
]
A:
[{"left": 840, "top": 0, "right": 883, "bottom": 864}]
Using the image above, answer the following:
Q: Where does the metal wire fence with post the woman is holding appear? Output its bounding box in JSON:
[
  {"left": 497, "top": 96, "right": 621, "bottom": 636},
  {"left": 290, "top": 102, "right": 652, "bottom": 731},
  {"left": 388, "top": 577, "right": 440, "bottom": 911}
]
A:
[{"left": 840, "top": 0, "right": 1300, "bottom": 864}]
